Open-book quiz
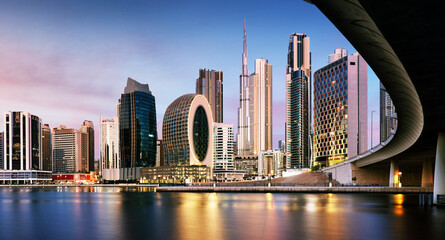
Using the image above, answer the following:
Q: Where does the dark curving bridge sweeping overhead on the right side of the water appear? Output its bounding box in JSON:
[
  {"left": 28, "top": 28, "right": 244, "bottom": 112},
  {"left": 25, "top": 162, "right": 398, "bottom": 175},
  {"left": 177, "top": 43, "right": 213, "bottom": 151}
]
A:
[{"left": 307, "top": 0, "right": 445, "bottom": 201}]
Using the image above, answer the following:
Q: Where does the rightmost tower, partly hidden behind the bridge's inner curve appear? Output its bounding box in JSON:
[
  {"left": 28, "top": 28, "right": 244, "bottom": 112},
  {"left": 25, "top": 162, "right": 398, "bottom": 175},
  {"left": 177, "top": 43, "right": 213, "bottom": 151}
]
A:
[{"left": 380, "top": 83, "right": 397, "bottom": 142}]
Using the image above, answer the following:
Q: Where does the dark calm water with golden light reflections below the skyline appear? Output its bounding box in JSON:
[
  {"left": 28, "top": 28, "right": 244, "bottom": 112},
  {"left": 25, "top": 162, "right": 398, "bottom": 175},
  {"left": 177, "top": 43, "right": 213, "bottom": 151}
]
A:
[{"left": 0, "top": 187, "right": 445, "bottom": 240}]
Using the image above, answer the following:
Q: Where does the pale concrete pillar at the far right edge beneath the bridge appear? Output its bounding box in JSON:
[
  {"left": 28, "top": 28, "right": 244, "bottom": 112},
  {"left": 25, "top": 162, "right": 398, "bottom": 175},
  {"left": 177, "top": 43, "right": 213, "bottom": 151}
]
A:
[{"left": 433, "top": 132, "right": 445, "bottom": 204}]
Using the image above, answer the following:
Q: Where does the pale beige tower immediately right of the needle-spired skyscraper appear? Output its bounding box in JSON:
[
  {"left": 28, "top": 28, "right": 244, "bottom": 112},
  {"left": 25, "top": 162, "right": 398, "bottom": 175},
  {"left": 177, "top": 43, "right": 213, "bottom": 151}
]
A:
[{"left": 250, "top": 59, "right": 272, "bottom": 155}]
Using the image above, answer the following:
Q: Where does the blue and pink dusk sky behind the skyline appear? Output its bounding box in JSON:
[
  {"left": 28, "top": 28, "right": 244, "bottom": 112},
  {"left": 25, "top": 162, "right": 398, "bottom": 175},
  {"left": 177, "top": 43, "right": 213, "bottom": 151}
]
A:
[{"left": 0, "top": 0, "right": 379, "bottom": 159}]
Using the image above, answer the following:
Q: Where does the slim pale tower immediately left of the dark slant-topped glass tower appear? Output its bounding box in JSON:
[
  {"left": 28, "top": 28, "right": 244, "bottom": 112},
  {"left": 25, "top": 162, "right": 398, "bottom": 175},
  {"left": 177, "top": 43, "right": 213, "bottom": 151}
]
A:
[{"left": 98, "top": 117, "right": 121, "bottom": 172}]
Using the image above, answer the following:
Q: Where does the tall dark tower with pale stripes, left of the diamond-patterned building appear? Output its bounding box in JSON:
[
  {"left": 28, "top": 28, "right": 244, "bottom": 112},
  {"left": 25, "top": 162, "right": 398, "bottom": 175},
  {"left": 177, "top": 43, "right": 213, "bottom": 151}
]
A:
[{"left": 286, "top": 33, "right": 312, "bottom": 169}]
